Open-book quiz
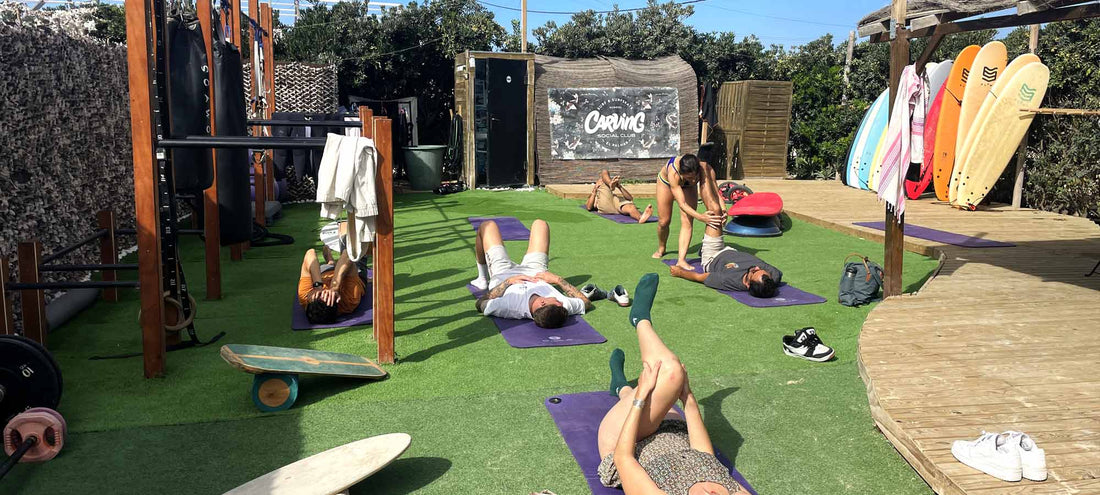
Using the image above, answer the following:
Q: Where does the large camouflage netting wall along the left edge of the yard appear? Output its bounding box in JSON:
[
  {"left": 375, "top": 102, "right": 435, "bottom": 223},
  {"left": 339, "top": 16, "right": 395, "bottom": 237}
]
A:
[{"left": 0, "top": 3, "right": 134, "bottom": 325}]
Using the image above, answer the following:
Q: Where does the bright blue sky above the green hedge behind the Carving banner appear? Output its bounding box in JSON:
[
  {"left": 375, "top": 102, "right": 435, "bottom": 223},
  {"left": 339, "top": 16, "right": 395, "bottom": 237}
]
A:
[{"left": 485, "top": 0, "right": 889, "bottom": 46}]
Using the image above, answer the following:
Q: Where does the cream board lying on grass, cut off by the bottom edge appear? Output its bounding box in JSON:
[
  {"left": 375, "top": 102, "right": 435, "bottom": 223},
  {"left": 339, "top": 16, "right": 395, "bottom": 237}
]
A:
[{"left": 226, "top": 433, "right": 413, "bottom": 495}]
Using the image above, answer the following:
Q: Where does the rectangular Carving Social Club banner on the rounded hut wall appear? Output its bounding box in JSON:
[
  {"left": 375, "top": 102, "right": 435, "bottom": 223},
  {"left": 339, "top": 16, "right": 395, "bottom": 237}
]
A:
[{"left": 547, "top": 88, "right": 680, "bottom": 160}]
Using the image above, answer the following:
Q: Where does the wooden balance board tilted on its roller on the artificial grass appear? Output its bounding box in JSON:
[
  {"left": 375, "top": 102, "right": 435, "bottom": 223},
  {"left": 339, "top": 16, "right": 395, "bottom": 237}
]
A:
[{"left": 221, "top": 344, "right": 387, "bottom": 413}]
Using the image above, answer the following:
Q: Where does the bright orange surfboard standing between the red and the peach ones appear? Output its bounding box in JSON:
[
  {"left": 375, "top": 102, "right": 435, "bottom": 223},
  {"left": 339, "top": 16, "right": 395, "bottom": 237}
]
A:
[{"left": 926, "top": 45, "right": 981, "bottom": 201}]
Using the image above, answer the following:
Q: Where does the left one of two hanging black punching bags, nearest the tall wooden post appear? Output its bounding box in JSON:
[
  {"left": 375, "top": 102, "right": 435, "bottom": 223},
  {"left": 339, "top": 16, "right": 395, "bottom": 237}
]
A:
[{"left": 167, "top": 13, "right": 213, "bottom": 193}]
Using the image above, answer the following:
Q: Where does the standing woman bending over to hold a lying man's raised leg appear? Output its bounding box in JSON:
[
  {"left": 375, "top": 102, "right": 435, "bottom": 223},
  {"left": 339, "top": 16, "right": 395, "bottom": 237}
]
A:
[{"left": 653, "top": 153, "right": 723, "bottom": 271}]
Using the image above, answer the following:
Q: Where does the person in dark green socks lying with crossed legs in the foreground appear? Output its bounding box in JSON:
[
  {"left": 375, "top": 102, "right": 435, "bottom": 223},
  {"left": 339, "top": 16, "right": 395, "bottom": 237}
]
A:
[{"left": 596, "top": 273, "right": 748, "bottom": 495}]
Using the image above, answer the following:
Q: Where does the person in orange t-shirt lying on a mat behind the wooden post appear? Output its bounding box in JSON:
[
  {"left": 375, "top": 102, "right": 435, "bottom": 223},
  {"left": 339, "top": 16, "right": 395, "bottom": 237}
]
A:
[{"left": 298, "top": 248, "right": 366, "bottom": 325}]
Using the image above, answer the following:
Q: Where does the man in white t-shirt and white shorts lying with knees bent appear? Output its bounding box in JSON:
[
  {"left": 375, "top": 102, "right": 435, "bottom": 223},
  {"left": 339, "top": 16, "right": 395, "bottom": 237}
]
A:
[{"left": 470, "top": 220, "right": 593, "bottom": 328}]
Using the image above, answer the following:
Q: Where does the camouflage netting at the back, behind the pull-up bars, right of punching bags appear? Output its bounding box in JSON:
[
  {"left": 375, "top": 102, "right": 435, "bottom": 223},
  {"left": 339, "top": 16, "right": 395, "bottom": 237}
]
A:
[{"left": 244, "top": 62, "right": 339, "bottom": 113}]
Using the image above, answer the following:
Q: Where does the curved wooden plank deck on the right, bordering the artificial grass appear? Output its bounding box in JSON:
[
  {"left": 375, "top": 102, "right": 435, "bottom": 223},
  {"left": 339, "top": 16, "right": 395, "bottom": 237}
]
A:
[{"left": 548, "top": 179, "right": 1100, "bottom": 495}]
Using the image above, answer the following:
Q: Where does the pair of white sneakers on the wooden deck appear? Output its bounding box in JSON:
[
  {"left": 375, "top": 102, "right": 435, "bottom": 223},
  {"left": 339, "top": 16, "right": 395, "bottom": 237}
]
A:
[{"left": 952, "top": 430, "right": 1046, "bottom": 482}]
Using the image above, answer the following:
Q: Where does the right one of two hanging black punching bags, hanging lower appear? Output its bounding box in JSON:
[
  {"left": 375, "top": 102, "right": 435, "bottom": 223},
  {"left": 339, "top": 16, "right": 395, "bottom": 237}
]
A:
[{"left": 207, "top": 25, "right": 252, "bottom": 245}]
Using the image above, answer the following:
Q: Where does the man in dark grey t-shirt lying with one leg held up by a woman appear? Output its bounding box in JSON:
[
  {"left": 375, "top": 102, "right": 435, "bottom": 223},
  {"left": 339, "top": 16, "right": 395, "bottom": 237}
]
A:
[{"left": 669, "top": 181, "right": 783, "bottom": 299}]
